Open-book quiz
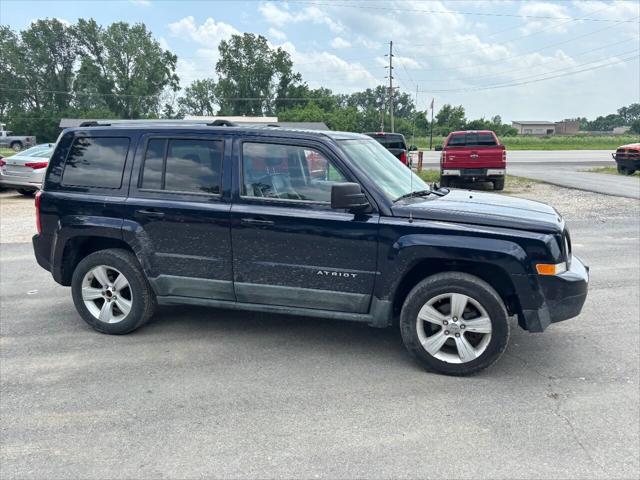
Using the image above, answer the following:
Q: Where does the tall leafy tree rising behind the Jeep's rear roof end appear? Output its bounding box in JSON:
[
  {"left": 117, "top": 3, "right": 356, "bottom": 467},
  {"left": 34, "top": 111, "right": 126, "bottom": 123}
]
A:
[{"left": 75, "top": 19, "right": 179, "bottom": 118}]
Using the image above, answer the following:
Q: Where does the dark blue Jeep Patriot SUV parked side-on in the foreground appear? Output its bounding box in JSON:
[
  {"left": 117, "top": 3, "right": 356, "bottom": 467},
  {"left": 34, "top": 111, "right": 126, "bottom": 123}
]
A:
[{"left": 33, "top": 123, "right": 588, "bottom": 375}]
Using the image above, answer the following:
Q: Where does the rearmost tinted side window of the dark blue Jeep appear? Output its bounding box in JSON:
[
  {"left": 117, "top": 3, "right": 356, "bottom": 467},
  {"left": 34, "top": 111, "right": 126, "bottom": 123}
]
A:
[{"left": 62, "top": 137, "right": 129, "bottom": 188}]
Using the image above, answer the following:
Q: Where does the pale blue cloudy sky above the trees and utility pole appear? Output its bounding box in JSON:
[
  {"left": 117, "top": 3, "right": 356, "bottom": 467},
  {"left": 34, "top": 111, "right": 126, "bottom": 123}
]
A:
[{"left": 0, "top": 0, "right": 640, "bottom": 121}]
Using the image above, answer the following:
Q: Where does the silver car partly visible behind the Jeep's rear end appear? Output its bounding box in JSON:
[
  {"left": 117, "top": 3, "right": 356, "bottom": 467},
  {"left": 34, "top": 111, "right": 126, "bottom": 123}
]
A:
[{"left": 0, "top": 143, "right": 55, "bottom": 196}]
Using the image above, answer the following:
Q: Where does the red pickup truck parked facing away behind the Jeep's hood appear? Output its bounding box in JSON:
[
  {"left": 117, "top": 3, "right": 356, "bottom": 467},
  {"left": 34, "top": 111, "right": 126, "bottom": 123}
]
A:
[{"left": 436, "top": 130, "right": 507, "bottom": 190}]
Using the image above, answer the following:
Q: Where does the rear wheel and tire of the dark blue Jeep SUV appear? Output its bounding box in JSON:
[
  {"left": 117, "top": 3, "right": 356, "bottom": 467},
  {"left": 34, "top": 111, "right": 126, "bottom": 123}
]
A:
[{"left": 71, "top": 248, "right": 156, "bottom": 335}]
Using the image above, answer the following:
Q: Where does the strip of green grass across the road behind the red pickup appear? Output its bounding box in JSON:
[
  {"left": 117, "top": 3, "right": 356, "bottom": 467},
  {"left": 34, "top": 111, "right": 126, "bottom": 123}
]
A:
[{"left": 407, "top": 135, "right": 640, "bottom": 150}]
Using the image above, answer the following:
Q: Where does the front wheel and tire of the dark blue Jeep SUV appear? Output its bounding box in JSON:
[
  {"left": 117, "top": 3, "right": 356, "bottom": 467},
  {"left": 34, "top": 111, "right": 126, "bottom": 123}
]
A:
[{"left": 400, "top": 272, "right": 509, "bottom": 376}]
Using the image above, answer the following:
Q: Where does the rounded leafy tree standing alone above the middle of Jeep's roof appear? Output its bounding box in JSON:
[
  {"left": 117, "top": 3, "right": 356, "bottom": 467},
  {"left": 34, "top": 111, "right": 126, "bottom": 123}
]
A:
[{"left": 216, "top": 33, "right": 302, "bottom": 116}]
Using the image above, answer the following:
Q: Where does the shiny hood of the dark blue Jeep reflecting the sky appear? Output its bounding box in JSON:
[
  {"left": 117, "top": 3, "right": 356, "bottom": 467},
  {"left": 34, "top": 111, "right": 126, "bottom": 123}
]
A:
[{"left": 392, "top": 190, "right": 564, "bottom": 233}]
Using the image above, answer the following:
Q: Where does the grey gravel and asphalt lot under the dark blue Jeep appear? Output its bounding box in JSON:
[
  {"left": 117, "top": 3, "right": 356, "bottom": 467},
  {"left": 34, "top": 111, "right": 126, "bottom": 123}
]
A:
[{"left": 0, "top": 181, "right": 640, "bottom": 479}]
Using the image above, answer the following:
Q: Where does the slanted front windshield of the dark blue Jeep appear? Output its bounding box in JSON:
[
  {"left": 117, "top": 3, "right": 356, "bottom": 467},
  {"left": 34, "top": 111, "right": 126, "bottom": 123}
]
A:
[{"left": 339, "top": 139, "right": 429, "bottom": 201}]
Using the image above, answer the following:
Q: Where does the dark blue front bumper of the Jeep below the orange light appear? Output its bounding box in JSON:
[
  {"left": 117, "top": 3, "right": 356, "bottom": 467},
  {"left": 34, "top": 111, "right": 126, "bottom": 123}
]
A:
[{"left": 520, "top": 256, "right": 589, "bottom": 332}]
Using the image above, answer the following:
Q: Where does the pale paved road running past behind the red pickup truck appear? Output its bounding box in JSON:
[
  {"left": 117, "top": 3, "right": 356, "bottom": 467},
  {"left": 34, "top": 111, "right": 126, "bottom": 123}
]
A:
[{"left": 412, "top": 150, "right": 640, "bottom": 199}]
